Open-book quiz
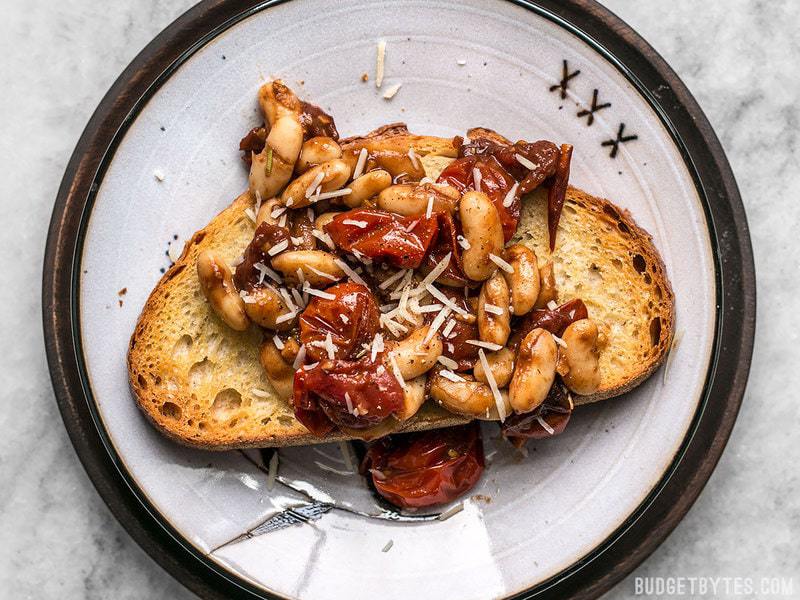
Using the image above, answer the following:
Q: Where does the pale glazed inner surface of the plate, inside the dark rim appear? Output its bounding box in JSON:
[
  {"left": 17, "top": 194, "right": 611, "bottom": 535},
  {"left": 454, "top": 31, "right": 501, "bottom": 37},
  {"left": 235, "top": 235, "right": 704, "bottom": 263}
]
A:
[{"left": 45, "top": 0, "right": 756, "bottom": 600}]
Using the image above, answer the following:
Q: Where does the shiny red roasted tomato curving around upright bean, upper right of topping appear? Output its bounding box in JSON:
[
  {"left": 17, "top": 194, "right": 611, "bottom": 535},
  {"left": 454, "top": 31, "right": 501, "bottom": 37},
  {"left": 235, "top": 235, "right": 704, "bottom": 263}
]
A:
[{"left": 437, "top": 155, "right": 520, "bottom": 242}]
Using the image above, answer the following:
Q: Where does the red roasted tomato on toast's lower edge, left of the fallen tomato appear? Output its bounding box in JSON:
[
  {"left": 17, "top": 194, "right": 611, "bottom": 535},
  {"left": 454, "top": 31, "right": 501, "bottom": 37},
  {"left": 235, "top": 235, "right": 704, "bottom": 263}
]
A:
[{"left": 292, "top": 356, "right": 403, "bottom": 436}]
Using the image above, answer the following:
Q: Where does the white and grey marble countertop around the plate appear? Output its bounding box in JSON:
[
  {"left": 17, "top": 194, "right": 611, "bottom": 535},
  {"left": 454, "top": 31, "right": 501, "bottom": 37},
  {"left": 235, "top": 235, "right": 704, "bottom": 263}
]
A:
[{"left": 0, "top": 0, "right": 800, "bottom": 600}]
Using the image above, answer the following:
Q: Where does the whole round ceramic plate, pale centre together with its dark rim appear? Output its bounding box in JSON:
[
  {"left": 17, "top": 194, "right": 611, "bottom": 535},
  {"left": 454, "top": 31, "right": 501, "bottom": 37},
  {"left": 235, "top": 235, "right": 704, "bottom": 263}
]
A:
[{"left": 44, "top": 0, "right": 754, "bottom": 600}]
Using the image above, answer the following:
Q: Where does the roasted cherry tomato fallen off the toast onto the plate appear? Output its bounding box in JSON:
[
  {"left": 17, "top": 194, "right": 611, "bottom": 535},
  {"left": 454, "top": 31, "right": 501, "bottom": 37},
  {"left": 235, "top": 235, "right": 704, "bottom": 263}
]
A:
[{"left": 362, "top": 422, "right": 484, "bottom": 508}]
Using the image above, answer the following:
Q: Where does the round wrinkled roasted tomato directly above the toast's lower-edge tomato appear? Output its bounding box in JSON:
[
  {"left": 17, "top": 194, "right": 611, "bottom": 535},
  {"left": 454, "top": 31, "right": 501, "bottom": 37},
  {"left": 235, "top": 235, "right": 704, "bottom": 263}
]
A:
[{"left": 300, "top": 283, "right": 380, "bottom": 361}]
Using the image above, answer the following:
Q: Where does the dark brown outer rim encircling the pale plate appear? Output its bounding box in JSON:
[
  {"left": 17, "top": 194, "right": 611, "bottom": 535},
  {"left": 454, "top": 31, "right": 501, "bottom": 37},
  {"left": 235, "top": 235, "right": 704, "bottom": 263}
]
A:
[{"left": 42, "top": 0, "right": 755, "bottom": 599}]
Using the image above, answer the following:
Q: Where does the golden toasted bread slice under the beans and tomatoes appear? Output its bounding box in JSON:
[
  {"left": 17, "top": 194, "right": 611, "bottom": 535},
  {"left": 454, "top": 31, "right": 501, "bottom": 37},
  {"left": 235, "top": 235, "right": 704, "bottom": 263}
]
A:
[{"left": 128, "top": 157, "right": 674, "bottom": 450}]
